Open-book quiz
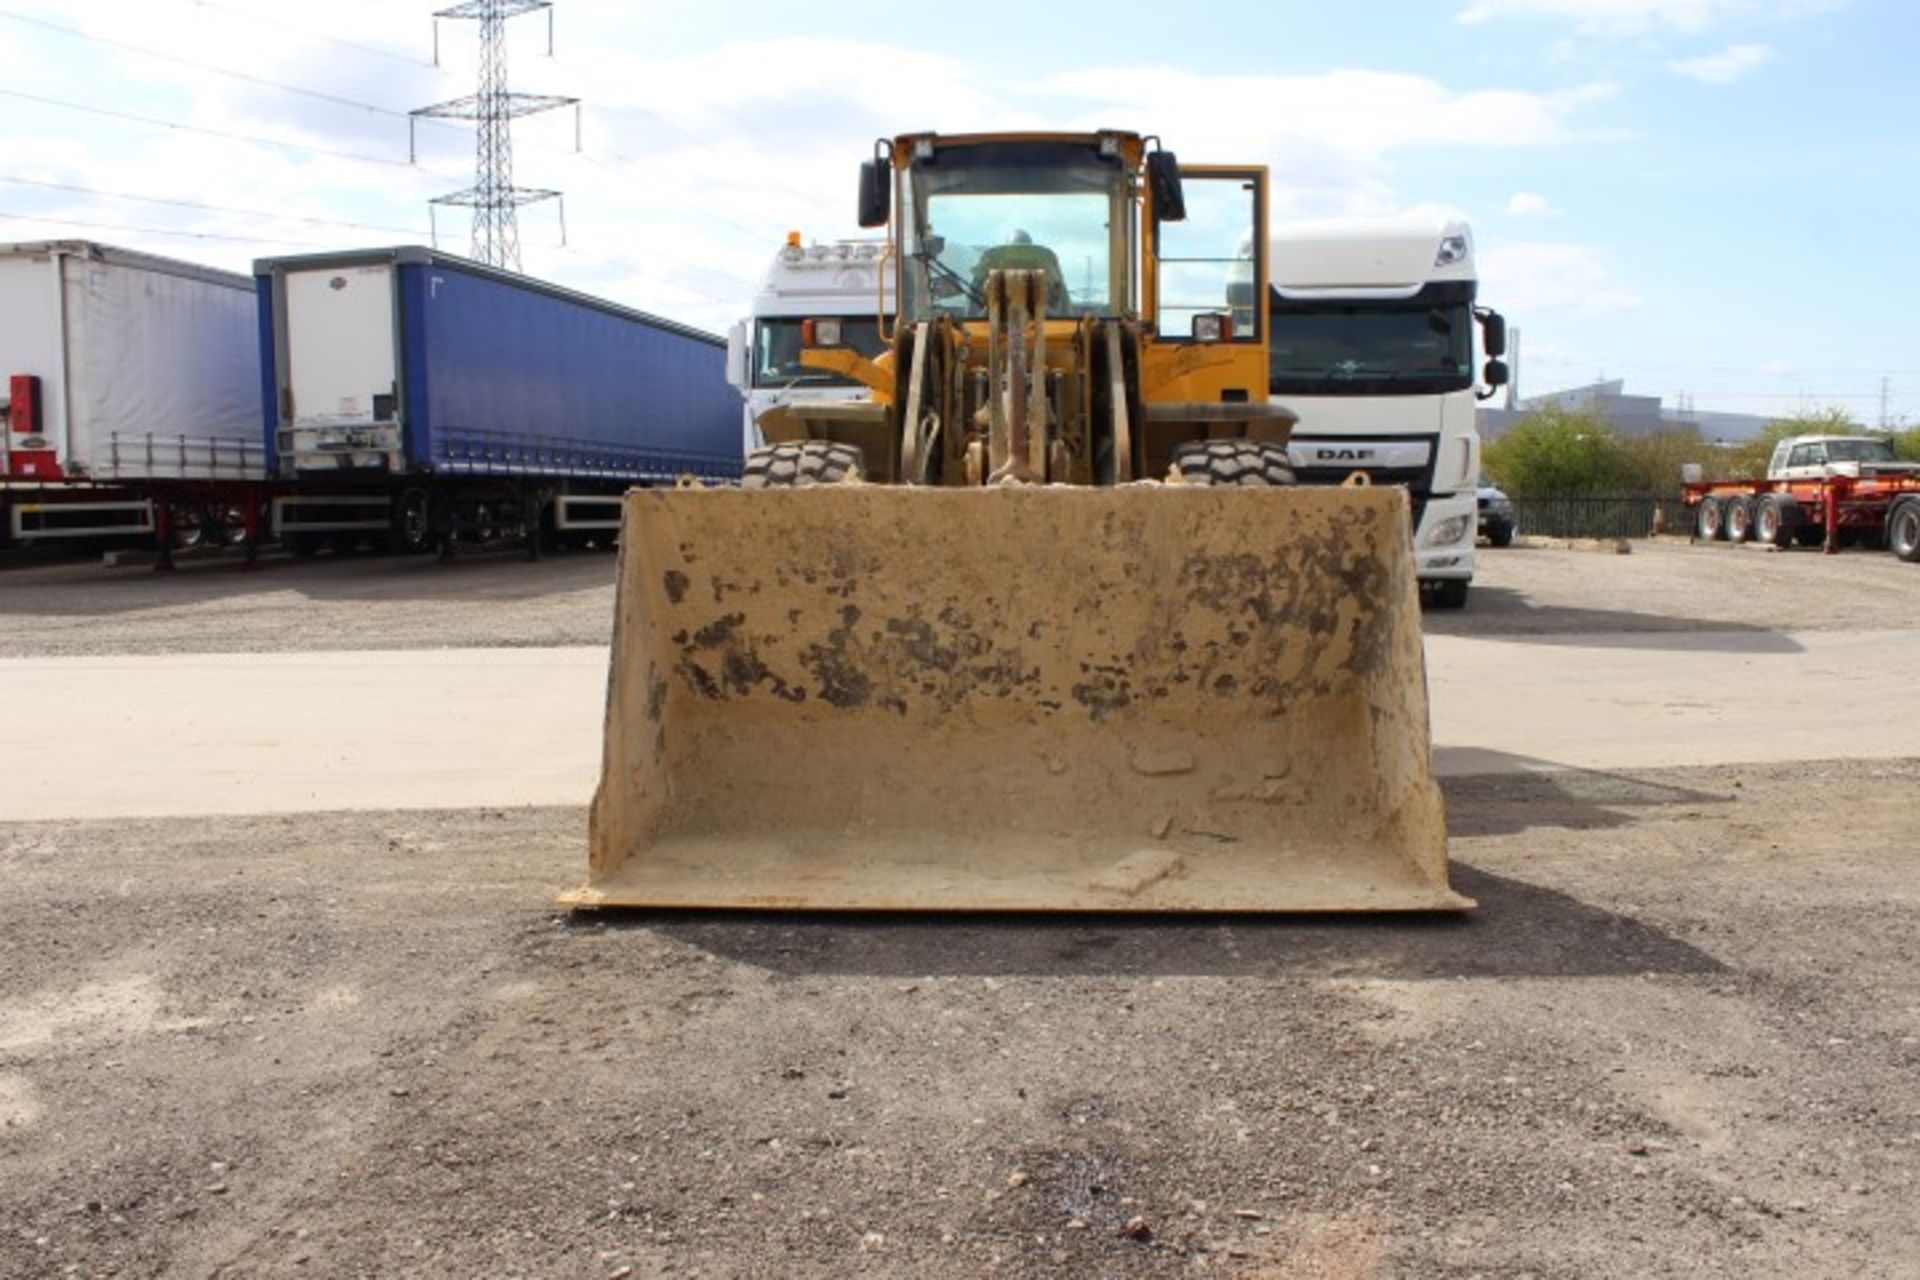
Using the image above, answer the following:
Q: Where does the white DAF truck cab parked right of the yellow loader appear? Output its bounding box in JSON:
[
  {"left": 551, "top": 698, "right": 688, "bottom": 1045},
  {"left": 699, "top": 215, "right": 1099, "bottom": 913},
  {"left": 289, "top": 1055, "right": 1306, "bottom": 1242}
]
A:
[{"left": 1267, "top": 221, "right": 1507, "bottom": 608}]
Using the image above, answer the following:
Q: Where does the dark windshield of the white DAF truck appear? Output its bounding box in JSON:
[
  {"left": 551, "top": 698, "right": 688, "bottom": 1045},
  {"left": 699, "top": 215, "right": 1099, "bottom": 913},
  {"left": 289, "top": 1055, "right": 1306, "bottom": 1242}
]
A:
[{"left": 1269, "top": 299, "right": 1473, "bottom": 395}]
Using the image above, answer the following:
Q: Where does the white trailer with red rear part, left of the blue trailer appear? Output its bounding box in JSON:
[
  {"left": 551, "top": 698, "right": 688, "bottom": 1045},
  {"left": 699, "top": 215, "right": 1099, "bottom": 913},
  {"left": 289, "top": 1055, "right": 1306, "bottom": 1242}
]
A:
[{"left": 0, "top": 240, "right": 267, "bottom": 541}]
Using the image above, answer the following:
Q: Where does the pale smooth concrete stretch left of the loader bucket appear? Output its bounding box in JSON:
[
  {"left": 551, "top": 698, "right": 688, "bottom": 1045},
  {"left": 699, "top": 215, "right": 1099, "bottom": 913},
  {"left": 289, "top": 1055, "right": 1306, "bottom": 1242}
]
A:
[{"left": 0, "top": 647, "right": 607, "bottom": 819}]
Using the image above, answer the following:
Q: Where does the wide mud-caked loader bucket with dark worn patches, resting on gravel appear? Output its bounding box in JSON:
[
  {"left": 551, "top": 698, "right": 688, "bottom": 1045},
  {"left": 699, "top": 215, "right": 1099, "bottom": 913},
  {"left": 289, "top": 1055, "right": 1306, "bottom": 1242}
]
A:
[{"left": 563, "top": 486, "right": 1473, "bottom": 912}]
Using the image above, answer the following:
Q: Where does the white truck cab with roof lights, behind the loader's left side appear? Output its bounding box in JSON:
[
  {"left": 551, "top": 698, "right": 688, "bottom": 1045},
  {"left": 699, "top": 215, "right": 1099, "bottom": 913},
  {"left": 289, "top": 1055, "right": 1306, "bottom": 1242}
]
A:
[{"left": 726, "top": 232, "right": 893, "bottom": 457}]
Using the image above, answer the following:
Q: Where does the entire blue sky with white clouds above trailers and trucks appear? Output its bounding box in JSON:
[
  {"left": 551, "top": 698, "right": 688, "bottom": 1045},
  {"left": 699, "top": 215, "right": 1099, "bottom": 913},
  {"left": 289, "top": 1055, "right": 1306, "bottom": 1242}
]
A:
[{"left": 0, "top": 0, "right": 1920, "bottom": 424}]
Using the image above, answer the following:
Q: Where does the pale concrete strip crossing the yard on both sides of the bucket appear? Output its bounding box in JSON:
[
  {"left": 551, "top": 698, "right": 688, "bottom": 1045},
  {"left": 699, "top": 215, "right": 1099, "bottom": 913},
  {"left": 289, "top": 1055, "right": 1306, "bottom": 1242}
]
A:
[{"left": 0, "top": 631, "right": 1920, "bottom": 821}]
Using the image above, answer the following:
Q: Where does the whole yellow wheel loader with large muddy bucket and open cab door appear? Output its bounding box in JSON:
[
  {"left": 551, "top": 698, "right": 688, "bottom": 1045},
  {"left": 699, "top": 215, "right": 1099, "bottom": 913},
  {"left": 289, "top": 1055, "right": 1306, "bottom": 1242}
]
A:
[{"left": 564, "top": 132, "right": 1471, "bottom": 912}]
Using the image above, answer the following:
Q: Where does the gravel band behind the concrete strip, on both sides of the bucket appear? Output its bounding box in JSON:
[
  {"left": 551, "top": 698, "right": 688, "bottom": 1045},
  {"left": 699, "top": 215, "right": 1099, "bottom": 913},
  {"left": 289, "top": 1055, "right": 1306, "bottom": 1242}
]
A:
[{"left": 0, "top": 541, "right": 1920, "bottom": 658}]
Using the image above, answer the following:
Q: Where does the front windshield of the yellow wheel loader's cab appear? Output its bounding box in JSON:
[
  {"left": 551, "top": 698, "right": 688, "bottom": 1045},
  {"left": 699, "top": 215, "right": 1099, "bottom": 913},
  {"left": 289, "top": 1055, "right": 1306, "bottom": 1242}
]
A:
[{"left": 902, "top": 142, "right": 1129, "bottom": 319}]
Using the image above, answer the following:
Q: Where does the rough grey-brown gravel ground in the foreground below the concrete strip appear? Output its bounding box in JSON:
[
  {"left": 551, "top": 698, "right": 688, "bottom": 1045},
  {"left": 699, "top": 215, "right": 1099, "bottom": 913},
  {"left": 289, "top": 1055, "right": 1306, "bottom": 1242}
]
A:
[{"left": 0, "top": 762, "right": 1920, "bottom": 1280}]
